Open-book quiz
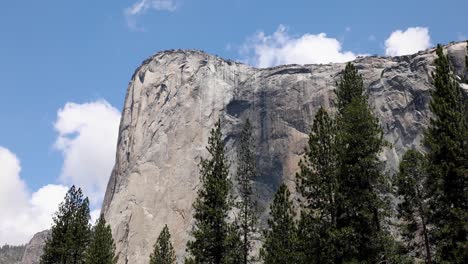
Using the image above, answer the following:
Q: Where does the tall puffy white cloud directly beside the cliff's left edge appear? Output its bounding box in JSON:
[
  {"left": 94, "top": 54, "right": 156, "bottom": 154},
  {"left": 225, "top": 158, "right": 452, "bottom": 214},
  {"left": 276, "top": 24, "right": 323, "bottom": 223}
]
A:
[{"left": 54, "top": 100, "right": 120, "bottom": 205}]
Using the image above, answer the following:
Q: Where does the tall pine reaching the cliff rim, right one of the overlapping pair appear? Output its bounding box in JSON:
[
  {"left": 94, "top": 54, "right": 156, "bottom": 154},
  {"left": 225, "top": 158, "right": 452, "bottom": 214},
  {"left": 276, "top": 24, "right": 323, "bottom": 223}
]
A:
[{"left": 336, "top": 63, "right": 392, "bottom": 263}]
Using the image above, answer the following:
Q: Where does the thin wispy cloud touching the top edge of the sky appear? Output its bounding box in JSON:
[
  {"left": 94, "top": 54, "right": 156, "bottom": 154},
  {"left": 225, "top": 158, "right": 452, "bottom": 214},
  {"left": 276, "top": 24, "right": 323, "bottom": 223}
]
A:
[{"left": 124, "top": 0, "right": 178, "bottom": 31}]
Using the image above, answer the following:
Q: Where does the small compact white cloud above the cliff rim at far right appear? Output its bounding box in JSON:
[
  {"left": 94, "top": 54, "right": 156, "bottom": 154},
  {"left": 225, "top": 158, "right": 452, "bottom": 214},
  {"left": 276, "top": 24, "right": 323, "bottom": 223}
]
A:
[{"left": 385, "top": 27, "right": 432, "bottom": 56}]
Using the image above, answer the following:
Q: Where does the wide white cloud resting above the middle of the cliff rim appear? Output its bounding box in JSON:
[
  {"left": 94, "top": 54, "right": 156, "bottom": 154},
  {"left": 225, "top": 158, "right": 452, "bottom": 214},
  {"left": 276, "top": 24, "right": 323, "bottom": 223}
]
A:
[{"left": 240, "top": 25, "right": 357, "bottom": 67}]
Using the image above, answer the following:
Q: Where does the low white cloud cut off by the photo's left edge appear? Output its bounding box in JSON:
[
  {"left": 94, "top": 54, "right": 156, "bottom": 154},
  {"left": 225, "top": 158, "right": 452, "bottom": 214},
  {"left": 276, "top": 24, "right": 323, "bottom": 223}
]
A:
[{"left": 0, "top": 147, "right": 68, "bottom": 245}]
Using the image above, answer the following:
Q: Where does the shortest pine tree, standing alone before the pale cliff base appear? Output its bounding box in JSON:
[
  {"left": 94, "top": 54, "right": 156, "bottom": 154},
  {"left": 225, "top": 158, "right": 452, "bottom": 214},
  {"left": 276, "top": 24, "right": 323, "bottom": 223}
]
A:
[{"left": 150, "top": 225, "right": 176, "bottom": 264}]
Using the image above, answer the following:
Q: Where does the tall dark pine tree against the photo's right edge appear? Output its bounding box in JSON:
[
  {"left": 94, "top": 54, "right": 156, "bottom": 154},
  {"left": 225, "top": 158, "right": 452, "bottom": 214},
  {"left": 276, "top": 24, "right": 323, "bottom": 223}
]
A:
[{"left": 424, "top": 45, "right": 468, "bottom": 263}]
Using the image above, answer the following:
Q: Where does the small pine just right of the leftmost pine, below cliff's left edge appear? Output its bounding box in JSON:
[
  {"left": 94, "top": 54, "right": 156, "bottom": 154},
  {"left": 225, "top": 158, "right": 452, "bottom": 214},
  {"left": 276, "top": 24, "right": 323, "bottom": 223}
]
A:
[{"left": 85, "top": 215, "right": 117, "bottom": 264}]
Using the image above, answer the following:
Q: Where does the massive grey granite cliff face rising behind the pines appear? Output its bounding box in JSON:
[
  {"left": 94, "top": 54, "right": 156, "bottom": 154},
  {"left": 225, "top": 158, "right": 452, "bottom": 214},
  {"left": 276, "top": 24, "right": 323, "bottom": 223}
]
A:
[{"left": 102, "top": 43, "right": 467, "bottom": 264}]
